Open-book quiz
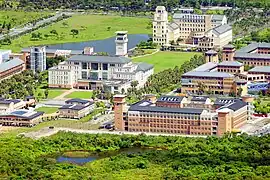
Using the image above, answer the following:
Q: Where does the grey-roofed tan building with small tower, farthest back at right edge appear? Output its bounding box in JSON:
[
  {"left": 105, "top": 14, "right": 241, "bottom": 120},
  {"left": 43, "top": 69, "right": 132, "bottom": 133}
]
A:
[{"left": 222, "top": 43, "right": 270, "bottom": 66}]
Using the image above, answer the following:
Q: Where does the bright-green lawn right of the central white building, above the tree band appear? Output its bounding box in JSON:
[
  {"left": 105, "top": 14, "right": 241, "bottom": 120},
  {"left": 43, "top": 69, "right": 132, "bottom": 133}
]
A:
[{"left": 133, "top": 52, "right": 201, "bottom": 73}]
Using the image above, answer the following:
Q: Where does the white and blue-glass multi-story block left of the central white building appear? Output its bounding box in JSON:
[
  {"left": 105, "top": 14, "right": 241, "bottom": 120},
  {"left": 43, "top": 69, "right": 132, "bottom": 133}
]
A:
[{"left": 30, "top": 46, "right": 46, "bottom": 72}]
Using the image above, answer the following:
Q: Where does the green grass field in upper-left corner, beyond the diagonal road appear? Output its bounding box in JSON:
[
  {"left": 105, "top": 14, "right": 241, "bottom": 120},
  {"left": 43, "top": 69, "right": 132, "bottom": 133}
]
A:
[{"left": 0, "top": 11, "right": 52, "bottom": 28}]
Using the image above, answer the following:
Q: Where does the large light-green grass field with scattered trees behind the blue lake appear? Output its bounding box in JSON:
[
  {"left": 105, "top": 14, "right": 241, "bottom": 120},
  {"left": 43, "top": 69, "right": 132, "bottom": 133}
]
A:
[{"left": 1, "top": 15, "right": 152, "bottom": 52}]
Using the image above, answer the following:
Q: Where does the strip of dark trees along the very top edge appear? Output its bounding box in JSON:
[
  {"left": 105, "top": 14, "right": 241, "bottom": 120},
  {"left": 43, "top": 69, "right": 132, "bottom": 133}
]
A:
[{"left": 0, "top": 0, "right": 269, "bottom": 10}]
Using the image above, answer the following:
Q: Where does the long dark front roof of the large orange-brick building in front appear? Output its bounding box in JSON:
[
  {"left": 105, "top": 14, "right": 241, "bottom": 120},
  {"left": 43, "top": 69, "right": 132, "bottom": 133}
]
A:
[{"left": 128, "top": 100, "right": 203, "bottom": 115}]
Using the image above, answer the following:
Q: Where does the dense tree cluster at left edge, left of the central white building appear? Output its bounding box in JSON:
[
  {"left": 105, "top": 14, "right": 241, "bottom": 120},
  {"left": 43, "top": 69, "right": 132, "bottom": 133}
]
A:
[{"left": 0, "top": 70, "right": 48, "bottom": 99}]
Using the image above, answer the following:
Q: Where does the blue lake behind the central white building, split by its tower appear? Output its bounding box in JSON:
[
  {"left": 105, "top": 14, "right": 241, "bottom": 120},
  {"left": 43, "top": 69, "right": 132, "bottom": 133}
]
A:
[{"left": 47, "top": 34, "right": 150, "bottom": 55}]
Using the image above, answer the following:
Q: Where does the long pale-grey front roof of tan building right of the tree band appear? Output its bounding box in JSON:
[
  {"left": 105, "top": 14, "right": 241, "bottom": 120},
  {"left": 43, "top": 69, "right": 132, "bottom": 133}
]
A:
[{"left": 182, "top": 71, "right": 234, "bottom": 78}]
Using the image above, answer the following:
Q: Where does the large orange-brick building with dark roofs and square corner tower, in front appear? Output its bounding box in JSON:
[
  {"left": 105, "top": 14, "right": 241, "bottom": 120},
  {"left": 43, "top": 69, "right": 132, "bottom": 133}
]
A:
[{"left": 114, "top": 95, "right": 248, "bottom": 136}]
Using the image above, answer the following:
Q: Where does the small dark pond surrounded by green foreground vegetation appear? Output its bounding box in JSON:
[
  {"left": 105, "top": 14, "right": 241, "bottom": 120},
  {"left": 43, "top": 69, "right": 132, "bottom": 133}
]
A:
[{"left": 56, "top": 148, "right": 157, "bottom": 165}]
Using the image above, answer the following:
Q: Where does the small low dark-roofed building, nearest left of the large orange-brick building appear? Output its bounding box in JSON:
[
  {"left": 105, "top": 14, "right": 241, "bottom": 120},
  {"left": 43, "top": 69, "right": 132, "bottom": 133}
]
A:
[{"left": 59, "top": 99, "right": 95, "bottom": 119}]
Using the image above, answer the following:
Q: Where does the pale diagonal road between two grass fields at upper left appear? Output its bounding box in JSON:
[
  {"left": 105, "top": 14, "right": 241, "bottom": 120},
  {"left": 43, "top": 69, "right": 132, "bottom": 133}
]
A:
[{"left": 0, "top": 13, "right": 73, "bottom": 40}]
